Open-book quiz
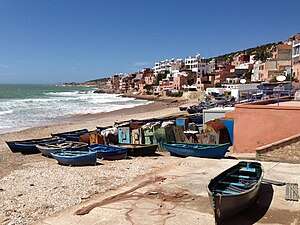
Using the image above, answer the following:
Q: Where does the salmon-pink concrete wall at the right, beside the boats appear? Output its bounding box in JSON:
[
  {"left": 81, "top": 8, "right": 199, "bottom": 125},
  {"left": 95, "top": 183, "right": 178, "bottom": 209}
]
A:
[{"left": 233, "top": 101, "right": 300, "bottom": 152}]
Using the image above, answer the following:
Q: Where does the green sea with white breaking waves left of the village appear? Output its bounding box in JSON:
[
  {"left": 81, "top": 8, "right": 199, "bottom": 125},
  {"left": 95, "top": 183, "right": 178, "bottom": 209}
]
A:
[{"left": 0, "top": 84, "right": 149, "bottom": 133}]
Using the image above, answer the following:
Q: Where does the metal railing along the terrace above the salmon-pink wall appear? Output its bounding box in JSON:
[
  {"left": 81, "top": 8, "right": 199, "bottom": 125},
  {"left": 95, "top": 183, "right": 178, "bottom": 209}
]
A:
[{"left": 238, "top": 89, "right": 297, "bottom": 104}]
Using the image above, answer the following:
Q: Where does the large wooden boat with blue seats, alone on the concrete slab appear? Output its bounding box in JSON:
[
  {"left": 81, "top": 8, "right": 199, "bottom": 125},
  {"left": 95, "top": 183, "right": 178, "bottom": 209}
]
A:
[{"left": 207, "top": 161, "right": 263, "bottom": 224}]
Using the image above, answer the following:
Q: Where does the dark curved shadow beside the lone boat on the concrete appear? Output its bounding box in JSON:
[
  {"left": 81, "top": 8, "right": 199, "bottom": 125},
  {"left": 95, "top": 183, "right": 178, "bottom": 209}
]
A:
[{"left": 221, "top": 184, "right": 274, "bottom": 225}]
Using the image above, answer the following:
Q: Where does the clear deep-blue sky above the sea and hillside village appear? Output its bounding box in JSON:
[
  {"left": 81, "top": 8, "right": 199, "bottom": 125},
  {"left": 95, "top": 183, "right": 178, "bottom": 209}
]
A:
[{"left": 0, "top": 0, "right": 300, "bottom": 83}]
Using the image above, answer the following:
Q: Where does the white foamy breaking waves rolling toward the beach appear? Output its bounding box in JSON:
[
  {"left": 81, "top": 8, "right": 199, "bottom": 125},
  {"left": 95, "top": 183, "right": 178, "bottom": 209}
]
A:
[{"left": 0, "top": 91, "right": 149, "bottom": 133}]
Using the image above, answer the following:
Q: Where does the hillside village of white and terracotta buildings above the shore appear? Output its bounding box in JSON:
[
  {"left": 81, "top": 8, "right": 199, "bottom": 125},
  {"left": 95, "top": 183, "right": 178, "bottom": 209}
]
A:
[{"left": 107, "top": 34, "right": 300, "bottom": 97}]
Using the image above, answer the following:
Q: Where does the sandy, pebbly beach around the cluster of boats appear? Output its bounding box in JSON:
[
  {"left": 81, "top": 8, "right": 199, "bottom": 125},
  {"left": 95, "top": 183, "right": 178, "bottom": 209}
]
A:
[{"left": 0, "top": 98, "right": 188, "bottom": 224}]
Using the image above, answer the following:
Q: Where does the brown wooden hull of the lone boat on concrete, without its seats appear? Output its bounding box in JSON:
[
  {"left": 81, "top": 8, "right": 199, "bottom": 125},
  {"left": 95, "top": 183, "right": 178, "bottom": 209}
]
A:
[{"left": 207, "top": 162, "right": 263, "bottom": 224}]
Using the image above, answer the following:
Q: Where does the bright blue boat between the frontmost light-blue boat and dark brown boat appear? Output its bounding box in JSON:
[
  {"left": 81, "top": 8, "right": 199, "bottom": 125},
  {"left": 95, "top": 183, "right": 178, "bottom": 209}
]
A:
[{"left": 89, "top": 144, "right": 127, "bottom": 160}]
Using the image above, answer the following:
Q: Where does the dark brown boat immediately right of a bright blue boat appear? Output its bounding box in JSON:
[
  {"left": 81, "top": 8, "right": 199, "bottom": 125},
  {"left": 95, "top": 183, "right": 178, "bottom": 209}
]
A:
[{"left": 118, "top": 144, "right": 158, "bottom": 156}]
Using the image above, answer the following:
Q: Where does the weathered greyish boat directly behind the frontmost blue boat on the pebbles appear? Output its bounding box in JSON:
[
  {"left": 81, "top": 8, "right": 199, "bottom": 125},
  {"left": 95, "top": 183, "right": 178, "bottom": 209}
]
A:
[{"left": 36, "top": 141, "right": 89, "bottom": 157}]
